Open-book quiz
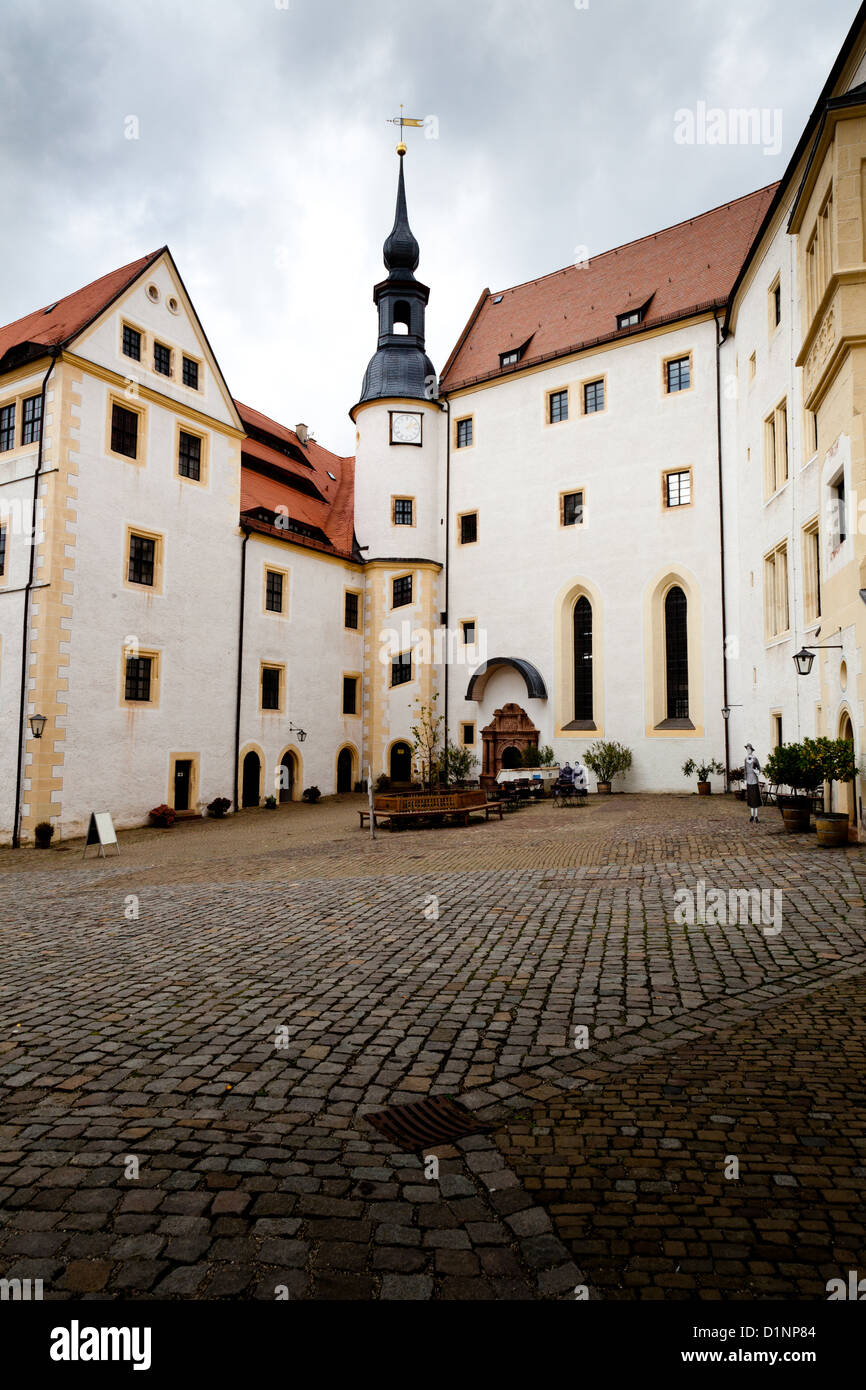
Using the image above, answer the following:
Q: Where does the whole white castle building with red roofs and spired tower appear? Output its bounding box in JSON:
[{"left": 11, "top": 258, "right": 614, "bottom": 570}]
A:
[{"left": 0, "top": 11, "right": 866, "bottom": 842}]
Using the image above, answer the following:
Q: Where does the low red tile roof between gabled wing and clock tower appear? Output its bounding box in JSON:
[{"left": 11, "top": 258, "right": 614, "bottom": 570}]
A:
[{"left": 235, "top": 400, "right": 354, "bottom": 557}]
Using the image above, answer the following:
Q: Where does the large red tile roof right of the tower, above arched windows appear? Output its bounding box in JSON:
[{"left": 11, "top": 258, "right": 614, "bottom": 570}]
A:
[{"left": 441, "top": 183, "right": 778, "bottom": 391}]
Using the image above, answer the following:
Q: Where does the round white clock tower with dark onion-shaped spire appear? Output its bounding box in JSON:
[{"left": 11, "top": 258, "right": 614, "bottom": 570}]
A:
[{"left": 350, "top": 143, "right": 446, "bottom": 781}]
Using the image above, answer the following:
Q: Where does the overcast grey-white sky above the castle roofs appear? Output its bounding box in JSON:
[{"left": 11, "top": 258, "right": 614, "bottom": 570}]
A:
[{"left": 0, "top": 0, "right": 858, "bottom": 453}]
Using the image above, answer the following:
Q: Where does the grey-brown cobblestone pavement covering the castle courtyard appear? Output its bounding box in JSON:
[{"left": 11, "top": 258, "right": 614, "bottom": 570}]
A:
[{"left": 0, "top": 796, "right": 866, "bottom": 1298}]
